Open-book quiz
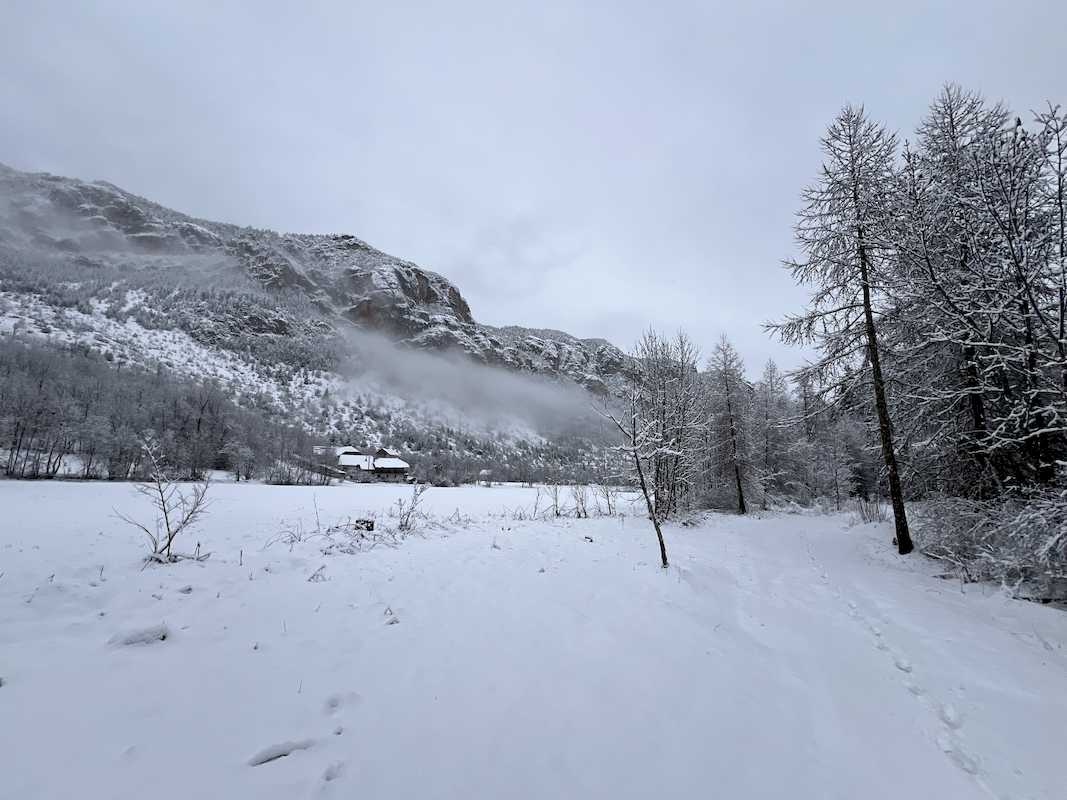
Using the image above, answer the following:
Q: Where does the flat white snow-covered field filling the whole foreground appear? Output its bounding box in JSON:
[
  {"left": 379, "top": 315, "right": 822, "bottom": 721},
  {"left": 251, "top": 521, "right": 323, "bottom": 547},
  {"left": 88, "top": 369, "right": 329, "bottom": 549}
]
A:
[{"left": 0, "top": 481, "right": 1067, "bottom": 800}]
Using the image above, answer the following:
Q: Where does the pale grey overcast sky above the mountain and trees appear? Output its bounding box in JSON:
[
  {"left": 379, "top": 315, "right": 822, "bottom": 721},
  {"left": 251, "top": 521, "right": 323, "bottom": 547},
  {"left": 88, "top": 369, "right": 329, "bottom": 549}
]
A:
[{"left": 0, "top": 0, "right": 1067, "bottom": 374}]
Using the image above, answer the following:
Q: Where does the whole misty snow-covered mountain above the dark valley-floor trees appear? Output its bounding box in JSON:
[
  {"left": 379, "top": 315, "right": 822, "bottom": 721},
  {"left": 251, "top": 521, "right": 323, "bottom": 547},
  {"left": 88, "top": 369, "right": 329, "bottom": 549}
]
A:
[{"left": 0, "top": 160, "right": 626, "bottom": 482}]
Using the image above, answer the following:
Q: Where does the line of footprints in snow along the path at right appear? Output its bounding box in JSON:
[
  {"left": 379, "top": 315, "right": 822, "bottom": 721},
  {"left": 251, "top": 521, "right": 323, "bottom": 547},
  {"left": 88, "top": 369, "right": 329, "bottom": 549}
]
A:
[{"left": 797, "top": 531, "right": 986, "bottom": 787}]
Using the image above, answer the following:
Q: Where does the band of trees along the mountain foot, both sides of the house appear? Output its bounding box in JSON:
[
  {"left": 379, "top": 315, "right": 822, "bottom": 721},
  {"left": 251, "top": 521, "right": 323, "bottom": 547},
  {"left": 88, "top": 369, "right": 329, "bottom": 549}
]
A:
[{"left": 0, "top": 336, "right": 621, "bottom": 485}]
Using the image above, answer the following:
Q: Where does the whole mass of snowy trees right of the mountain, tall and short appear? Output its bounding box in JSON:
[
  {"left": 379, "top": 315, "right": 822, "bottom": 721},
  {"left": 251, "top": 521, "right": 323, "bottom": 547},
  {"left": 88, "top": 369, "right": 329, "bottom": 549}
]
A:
[{"left": 620, "top": 86, "right": 1067, "bottom": 591}]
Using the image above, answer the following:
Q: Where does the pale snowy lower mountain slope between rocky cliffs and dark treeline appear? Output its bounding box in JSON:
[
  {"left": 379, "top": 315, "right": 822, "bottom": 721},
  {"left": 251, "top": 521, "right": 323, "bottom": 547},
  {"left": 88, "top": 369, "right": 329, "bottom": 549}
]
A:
[{"left": 0, "top": 285, "right": 614, "bottom": 478}]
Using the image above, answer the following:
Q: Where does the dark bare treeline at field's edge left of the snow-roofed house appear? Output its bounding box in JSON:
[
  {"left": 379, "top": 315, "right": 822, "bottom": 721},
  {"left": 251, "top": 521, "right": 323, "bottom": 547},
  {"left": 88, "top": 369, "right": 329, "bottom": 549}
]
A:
[{"left": 0, "top": 337, "right": 327, "bottom": 483}]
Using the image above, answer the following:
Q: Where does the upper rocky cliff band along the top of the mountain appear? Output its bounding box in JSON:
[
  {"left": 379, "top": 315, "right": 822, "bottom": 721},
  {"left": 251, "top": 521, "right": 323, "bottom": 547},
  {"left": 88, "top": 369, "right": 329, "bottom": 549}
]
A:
[{"left": 0, "top": 165, "right": 626, "bottom": 394}]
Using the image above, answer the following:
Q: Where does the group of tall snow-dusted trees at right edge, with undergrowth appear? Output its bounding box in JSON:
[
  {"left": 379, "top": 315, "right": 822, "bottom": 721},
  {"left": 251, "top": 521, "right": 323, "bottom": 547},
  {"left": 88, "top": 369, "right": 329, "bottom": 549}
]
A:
[{"left": 779, "top": 86, "right": 1067, "bottom": 592}]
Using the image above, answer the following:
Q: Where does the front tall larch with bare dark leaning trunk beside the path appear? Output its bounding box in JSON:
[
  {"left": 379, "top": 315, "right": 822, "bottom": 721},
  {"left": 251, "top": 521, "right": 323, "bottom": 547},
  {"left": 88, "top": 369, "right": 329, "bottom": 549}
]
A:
[{"left": 771, "top": 106, "right": 914, "bottom": 555}]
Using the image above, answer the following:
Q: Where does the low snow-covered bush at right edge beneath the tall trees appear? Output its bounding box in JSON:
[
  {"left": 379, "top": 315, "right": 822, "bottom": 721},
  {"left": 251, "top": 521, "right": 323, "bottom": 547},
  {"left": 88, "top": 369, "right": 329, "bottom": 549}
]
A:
[{"left": 913, "top": 490, "right": 1067, "bottom": 598}]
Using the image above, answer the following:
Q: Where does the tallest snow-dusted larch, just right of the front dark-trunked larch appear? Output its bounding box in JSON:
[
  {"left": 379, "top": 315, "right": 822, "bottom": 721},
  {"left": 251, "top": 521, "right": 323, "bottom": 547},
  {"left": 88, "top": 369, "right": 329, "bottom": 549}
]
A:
[{"left": 883, "top": 86, "right": 1007, "bottom": 495}]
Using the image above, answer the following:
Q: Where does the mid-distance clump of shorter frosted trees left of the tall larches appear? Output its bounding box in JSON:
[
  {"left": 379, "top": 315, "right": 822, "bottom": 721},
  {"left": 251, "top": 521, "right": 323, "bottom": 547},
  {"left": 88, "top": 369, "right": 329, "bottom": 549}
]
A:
[{"left": 605, "top": 331, "right": 879, "bottom": 522}]
